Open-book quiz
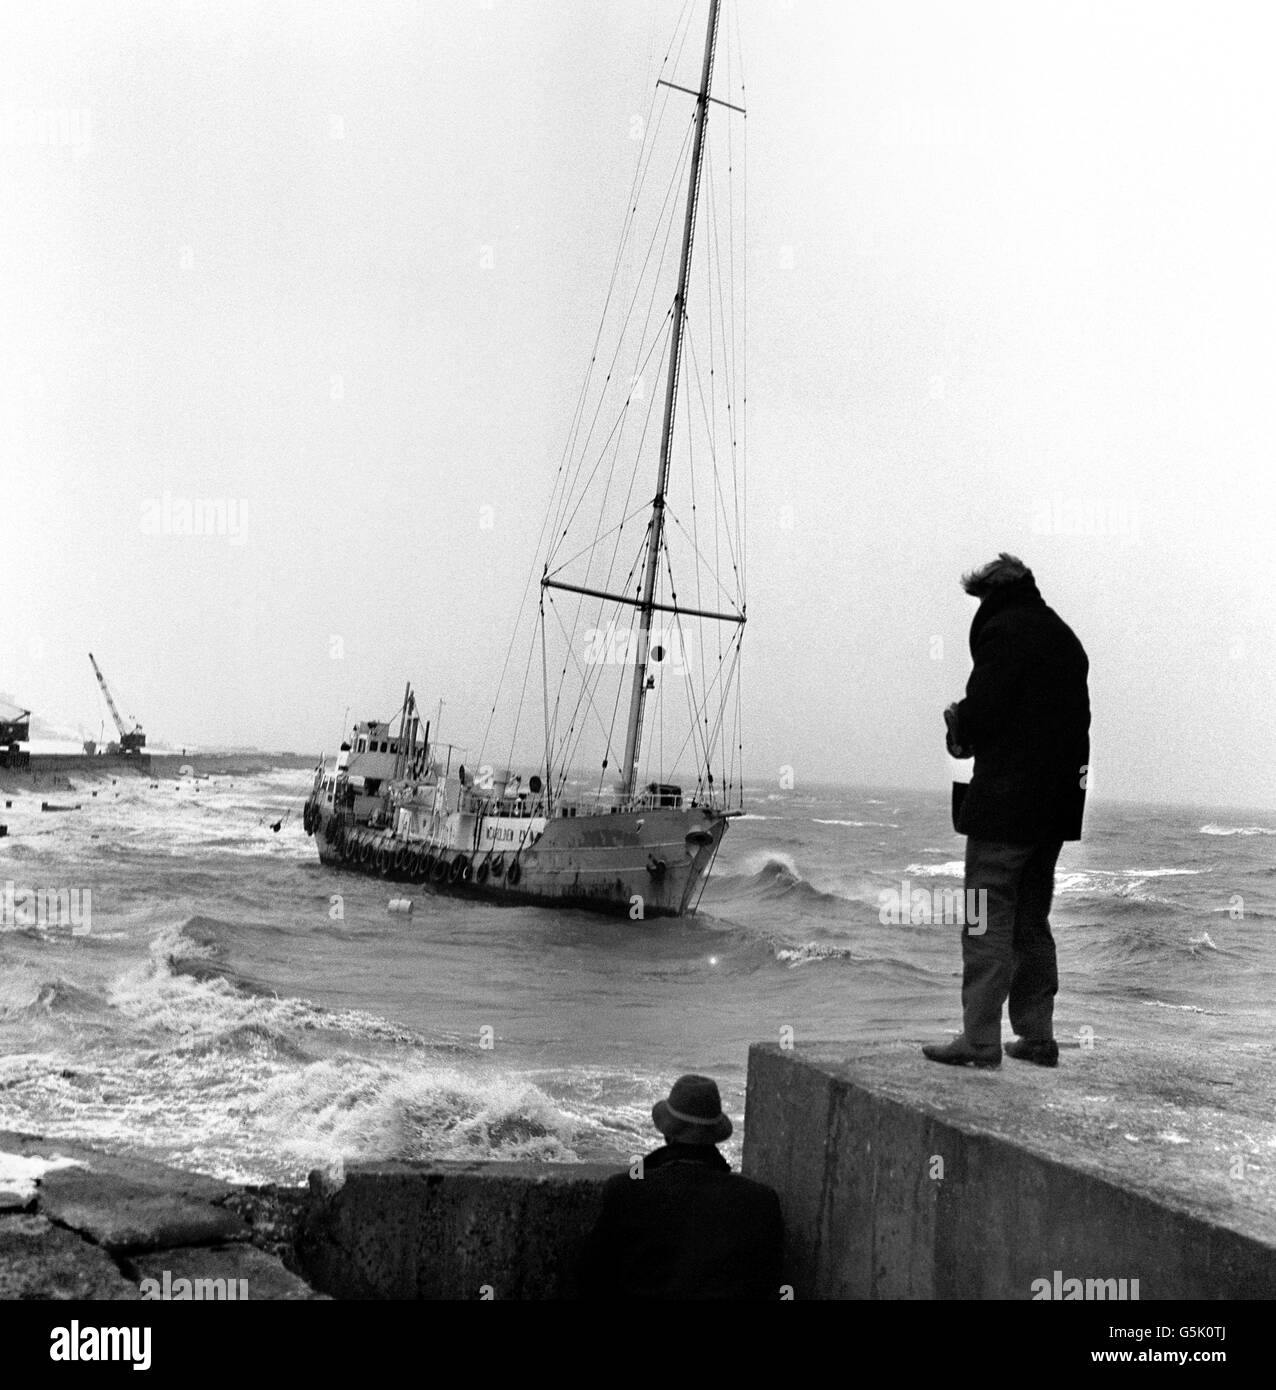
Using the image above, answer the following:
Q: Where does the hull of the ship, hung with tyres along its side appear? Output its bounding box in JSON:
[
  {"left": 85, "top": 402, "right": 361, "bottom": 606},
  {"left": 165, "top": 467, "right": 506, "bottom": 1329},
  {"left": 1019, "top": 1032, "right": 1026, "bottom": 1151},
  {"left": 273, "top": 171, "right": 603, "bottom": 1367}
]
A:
[{"left": 314, "top": 806, "right": 727, "bottom": 920}]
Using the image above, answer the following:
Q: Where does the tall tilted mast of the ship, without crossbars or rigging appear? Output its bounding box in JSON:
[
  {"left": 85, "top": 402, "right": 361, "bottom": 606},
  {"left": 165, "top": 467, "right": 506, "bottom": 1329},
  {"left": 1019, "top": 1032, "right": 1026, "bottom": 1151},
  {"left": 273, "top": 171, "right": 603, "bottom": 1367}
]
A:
[{"left": 620, "top": 0, "right": 720, "bottom": 801}]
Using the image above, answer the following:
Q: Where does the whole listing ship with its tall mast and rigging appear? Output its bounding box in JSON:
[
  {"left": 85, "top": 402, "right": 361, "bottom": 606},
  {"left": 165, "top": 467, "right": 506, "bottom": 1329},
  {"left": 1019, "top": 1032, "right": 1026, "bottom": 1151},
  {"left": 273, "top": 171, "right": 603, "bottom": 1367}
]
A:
[{"left": 303, "top": 0, "right": 746, "bottom": 920}]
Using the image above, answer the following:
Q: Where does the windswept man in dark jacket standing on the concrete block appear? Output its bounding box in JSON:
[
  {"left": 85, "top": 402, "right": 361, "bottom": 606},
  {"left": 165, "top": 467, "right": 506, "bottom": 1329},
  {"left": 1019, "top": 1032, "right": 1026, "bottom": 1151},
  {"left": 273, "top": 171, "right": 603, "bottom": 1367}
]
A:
[{"left": 922, "top": 552, "right": 1090, "bottom": 1066}]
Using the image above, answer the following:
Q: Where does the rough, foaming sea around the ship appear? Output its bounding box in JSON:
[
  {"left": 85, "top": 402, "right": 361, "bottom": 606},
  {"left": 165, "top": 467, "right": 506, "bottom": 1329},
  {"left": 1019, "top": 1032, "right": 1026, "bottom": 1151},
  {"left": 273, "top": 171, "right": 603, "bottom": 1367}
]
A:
[{"left": 0, "top": 770, "right": 1276, "bottom": 1182}]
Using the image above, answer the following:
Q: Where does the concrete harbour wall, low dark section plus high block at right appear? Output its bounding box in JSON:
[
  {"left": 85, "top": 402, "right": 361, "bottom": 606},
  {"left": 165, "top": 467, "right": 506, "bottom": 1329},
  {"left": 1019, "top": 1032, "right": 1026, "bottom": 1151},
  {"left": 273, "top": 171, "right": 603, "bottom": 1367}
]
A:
[{"left": 297, "top": 1043, "right": 1276, "bottom": 1301}]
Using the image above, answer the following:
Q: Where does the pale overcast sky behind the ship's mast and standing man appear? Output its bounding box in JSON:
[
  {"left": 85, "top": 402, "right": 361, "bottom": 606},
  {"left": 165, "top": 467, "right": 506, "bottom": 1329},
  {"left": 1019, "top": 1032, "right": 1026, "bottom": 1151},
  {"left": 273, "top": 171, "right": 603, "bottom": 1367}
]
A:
[{"left": 0, "top": 0, "right": 1276, "bottom": 806}]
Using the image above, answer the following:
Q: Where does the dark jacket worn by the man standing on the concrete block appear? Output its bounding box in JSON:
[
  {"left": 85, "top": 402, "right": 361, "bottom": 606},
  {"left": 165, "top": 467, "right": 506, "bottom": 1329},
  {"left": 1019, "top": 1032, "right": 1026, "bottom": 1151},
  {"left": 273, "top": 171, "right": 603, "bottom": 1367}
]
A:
[{"left": 954, "top": 580, "right": 1090, "bottom": 844}]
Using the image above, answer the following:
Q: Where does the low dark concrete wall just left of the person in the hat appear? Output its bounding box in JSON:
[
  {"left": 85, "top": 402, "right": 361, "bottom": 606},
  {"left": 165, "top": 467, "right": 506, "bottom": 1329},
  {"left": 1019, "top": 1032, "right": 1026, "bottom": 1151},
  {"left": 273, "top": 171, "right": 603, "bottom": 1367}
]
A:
[{"left": 297, "top": 1162, "right": 620, "bottom": 1300}]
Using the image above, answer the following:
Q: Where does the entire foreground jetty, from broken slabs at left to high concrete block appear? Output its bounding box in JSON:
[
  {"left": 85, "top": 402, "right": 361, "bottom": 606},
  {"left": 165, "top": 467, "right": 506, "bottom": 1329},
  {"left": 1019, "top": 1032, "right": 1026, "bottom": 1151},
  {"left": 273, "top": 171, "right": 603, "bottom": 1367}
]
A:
[{"left": 0, "top": 1040, "right": 1276, "bottom": 1301}]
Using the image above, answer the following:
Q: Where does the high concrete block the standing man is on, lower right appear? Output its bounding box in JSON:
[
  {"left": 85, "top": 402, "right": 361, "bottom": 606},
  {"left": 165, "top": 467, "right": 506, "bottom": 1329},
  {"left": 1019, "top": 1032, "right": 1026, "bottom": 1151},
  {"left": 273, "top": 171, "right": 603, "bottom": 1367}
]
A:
[{"left": 744, "top": 1043, "right": 1276, "bottom": 1300}]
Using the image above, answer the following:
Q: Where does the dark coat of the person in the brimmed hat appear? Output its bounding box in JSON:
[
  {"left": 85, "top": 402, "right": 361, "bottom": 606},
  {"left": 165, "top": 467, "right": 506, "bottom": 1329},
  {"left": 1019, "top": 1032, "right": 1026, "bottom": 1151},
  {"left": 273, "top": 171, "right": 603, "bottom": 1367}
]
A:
[{"left": 580, "top": 1144, "right": 784, "bottom": 1298}]
